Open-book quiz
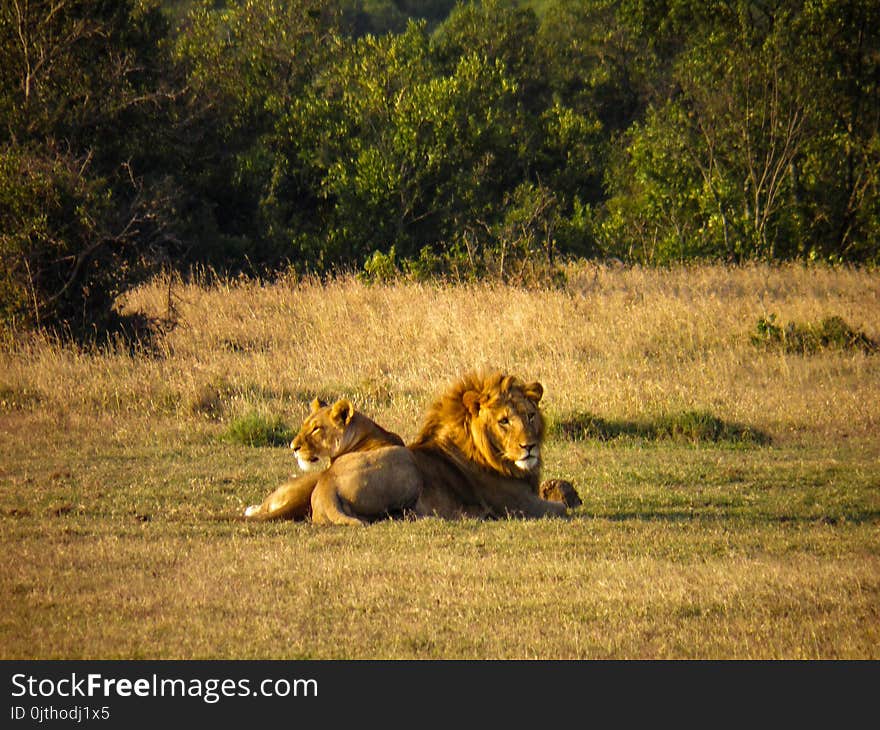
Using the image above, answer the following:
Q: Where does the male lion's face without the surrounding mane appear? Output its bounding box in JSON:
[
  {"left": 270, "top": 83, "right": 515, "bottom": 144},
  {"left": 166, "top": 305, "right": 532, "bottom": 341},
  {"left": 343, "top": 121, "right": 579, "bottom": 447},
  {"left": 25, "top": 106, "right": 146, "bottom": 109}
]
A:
[{"left": 471, "top": 386, "right": 544, "bottom": 473}]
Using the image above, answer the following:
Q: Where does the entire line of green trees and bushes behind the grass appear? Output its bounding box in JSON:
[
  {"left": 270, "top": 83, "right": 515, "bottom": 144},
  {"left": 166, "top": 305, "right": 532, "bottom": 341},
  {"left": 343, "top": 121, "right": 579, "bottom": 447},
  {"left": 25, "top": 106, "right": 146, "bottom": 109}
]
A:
[{"left": 0, "top": 0, "right": 880, "bottom": 331}]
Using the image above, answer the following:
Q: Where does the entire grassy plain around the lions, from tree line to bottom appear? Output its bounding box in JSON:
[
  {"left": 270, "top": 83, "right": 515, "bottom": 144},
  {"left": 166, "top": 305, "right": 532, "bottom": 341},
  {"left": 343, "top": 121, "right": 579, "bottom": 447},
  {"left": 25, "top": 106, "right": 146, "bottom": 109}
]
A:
[{"left": 0, "top": 265, "right": 880, "bottom": 659}]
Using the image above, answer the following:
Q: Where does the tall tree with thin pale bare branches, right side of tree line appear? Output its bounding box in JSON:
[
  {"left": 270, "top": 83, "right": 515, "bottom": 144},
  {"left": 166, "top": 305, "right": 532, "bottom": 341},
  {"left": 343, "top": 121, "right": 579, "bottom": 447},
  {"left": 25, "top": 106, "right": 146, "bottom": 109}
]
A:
[{"left": 676, "top": 13, "right": 815, "bottom": 259}]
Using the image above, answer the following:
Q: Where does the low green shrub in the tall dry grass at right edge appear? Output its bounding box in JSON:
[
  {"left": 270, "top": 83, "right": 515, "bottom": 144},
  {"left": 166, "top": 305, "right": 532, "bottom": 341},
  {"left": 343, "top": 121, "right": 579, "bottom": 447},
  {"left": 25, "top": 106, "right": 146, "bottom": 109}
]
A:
[{"left": 752, "top": 314, "right": 880, "bottom": 355}]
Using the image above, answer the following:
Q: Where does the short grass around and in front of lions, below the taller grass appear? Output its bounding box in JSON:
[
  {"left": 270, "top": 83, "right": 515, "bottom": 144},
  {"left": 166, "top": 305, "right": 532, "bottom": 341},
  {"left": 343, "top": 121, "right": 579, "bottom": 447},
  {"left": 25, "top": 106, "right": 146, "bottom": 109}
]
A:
[{"left": 0, "top": 412, "right": 880, "bottom": 659}]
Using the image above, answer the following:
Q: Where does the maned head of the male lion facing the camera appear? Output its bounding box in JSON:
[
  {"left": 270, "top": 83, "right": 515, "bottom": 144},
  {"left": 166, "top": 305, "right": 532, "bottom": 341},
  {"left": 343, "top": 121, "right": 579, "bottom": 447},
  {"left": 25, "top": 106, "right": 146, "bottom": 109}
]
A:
[{"left": 461, "top": 374, "right": 544, "bottom": 476}]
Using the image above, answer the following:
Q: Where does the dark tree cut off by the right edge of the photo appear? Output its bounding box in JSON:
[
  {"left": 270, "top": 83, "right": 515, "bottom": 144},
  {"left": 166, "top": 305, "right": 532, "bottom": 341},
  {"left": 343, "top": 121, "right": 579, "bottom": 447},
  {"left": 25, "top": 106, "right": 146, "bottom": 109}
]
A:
[{"left": 792, "top": 0, "right": 880, "bottom": 262}]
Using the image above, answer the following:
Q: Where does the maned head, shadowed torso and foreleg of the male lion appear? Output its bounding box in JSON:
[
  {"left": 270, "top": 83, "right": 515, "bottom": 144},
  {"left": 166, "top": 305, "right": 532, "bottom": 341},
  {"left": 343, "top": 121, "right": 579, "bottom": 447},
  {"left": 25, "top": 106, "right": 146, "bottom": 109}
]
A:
[{"left": 409, "top": 372, "right": 566, "bottom": 518}]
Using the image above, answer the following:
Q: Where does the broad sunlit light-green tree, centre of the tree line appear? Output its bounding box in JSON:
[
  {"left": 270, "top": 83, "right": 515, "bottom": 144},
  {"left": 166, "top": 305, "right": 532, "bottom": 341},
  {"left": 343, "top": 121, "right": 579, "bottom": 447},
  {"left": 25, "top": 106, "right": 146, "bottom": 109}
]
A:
[{"left": 279, "top": 24, "right": 515, "bottom": 263}]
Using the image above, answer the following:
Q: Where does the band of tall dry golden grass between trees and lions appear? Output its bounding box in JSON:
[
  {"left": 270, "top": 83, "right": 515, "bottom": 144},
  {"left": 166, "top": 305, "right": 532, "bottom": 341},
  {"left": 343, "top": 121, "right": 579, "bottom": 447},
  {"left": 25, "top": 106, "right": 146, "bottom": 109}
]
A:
[{"left": 0, "top": 265, "right": 880, "bottom": 438}]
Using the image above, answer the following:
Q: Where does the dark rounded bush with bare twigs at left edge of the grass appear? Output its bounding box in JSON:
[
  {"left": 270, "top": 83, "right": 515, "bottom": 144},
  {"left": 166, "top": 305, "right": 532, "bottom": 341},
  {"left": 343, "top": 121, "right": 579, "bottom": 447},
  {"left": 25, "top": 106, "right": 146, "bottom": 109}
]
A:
[{"left": 0, "top": 147, "right": 179, "bottom": 338}]
